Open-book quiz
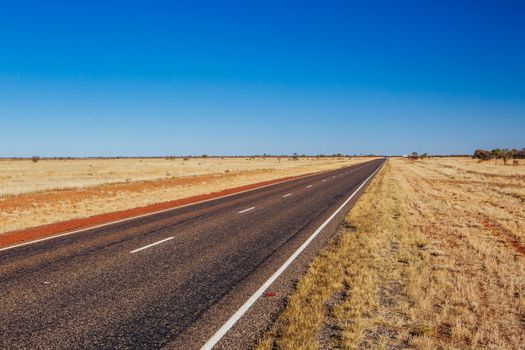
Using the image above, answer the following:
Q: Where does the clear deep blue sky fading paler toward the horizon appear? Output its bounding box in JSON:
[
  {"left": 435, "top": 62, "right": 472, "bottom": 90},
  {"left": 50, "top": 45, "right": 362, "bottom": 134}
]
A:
[{"left": 0, "top": 0, "right": 525, "bottom": 156}]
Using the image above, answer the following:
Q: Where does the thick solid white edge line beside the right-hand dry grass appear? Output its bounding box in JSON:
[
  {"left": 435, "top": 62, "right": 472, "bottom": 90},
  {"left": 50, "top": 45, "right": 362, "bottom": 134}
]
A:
[{"left": 201, "top": 163, "right": 384, "bottom": 350}]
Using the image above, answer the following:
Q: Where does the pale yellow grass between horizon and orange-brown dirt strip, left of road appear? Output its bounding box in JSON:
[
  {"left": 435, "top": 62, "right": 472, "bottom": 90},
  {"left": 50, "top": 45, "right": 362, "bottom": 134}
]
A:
[{"left": 0, "top": 157, "right": 364, "bottom": 196}]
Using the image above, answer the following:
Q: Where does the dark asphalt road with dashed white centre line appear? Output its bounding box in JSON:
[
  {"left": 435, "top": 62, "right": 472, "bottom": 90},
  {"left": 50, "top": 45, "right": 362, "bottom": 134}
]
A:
[{"left": 0, "top": 159, "right": 384, "bottom": 349}]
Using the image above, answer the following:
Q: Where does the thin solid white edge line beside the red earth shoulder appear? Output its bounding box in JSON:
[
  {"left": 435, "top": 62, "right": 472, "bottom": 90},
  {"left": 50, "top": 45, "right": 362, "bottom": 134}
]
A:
[{"left": 0, "top": 169, "right": 338, "bottom": 252}]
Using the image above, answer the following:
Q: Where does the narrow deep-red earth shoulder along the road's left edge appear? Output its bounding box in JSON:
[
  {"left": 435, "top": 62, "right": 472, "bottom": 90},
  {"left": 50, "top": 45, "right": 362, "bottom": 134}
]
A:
[{"left": 0, "top": 174, "right": 311, "bottom": 247}]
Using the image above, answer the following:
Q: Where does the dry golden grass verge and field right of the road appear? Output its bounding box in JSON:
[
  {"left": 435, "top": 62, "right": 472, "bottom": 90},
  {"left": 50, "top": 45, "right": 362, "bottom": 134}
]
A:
[{"left": 258, "top": 158, "right": 525, "bottom": 350}]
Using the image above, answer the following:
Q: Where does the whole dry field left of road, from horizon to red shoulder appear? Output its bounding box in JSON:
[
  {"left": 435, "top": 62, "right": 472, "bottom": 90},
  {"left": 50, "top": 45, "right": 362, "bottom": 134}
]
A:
[{"left": 0, "top": 157, "right": 370, "bottom": 233}]
